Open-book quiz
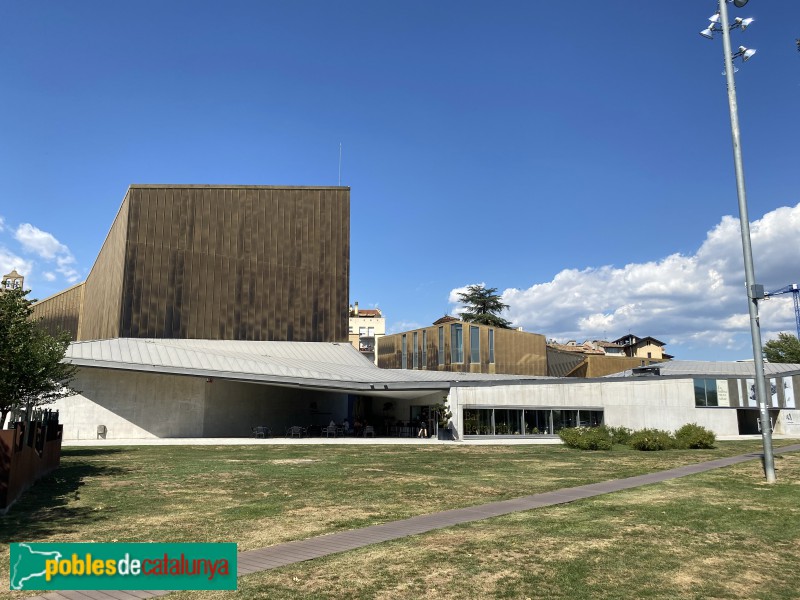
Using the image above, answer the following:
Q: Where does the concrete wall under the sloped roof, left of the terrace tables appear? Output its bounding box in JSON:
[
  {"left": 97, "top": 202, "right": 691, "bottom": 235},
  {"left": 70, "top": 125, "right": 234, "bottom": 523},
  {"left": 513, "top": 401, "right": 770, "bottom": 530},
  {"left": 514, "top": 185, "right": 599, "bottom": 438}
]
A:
[{"left": 53, "top": 368, "right": 347, "bottom": 440}]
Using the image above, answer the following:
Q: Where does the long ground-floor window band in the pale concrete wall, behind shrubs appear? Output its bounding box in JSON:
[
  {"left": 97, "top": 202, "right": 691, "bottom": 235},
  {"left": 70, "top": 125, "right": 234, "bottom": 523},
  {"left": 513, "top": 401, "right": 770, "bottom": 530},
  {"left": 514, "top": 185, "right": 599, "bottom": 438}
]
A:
[{"left": 463, "top": 408, "right": 603, "bottom": 435}]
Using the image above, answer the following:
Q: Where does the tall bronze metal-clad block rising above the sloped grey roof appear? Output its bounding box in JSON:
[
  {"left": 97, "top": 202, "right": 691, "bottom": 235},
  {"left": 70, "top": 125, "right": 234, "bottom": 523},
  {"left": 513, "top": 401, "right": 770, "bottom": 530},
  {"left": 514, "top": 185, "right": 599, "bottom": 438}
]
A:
[{"left": 32, "top": 185, "right": 350, "bottom": 342}]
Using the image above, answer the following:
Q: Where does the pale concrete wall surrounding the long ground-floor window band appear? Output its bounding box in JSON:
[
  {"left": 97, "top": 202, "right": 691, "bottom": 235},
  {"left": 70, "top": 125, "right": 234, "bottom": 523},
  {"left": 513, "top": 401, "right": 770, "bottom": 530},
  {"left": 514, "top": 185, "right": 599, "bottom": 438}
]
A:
[{"left": 450, "top": 379, "right": 739, "bottom": 435}]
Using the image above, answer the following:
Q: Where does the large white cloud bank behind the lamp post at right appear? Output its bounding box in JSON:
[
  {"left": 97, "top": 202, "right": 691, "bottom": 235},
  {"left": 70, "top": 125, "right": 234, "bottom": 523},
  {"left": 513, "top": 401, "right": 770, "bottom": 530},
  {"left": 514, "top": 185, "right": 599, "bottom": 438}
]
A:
[{"left": 450, "top": 204, "right": 800, "bottom": 358}]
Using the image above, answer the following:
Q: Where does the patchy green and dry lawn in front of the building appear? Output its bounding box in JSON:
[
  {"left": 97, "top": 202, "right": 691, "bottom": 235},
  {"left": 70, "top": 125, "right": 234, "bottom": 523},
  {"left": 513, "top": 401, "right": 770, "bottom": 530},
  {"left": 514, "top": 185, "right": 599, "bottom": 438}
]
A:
[{"left": 0, "top": 441, "right": 800, "bottom": 598}]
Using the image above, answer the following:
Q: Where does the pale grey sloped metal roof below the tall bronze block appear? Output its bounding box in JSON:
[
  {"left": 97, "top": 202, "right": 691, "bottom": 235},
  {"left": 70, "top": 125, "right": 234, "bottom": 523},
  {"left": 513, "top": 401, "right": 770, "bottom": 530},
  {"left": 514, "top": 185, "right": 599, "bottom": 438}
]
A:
[{"left": 65, "top": 338, "right": 535, "bottom": 390}]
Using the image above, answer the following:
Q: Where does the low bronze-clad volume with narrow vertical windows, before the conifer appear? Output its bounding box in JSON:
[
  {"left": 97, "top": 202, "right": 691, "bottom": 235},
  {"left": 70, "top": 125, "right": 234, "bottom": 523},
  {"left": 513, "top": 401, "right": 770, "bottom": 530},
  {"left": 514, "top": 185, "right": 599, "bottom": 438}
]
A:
[{"left": 378, "top": 316, "right": 547, "bottom": 376}]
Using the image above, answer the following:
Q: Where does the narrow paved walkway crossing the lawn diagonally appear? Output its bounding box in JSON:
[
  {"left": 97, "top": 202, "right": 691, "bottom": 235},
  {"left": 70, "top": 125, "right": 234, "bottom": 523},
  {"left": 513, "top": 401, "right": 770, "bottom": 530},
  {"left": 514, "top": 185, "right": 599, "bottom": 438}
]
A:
[{"left": 25, "top": 444, "right": 800, "bottom": 600}]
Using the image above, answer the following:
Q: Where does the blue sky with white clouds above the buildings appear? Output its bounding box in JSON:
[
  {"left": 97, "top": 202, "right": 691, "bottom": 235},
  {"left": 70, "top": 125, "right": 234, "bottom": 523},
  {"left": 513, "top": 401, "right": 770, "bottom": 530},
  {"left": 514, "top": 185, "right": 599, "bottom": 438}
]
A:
[{"left": 0, "top": 0, "right": 800, "bottom": 360}]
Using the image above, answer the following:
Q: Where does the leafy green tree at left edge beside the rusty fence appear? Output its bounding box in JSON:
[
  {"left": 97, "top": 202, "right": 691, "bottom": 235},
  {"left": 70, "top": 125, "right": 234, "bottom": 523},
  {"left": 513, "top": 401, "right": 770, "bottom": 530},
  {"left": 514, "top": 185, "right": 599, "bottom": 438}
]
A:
[{"left": 0, "top": 289, "right": 76, "bottom": 428}]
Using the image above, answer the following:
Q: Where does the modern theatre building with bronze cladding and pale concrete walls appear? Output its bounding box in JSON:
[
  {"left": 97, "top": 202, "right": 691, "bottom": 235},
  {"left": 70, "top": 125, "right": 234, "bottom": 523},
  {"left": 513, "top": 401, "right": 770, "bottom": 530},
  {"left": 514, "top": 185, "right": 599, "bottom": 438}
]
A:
[{"left": 28, "top": 185, "right": 800, "bottom": 439}]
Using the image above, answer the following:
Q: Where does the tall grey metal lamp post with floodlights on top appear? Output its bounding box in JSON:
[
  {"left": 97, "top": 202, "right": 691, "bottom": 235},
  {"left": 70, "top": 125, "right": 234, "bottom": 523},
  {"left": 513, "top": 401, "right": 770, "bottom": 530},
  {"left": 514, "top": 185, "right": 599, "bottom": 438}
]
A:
[{"left": 701, "top": 0, "right": 775, "bottom": 483}]
